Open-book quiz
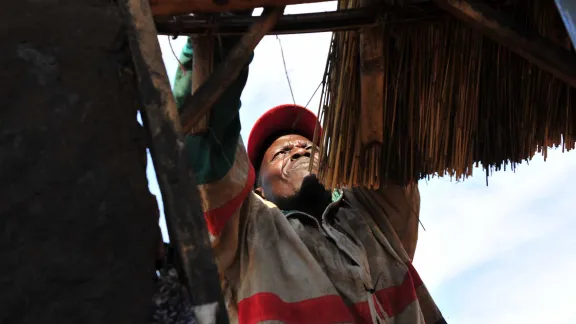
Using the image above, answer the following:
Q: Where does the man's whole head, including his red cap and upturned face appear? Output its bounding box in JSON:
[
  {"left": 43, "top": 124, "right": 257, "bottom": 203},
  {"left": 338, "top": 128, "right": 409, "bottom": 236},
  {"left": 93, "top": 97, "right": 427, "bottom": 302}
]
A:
[{"left": 248, "top": 105, "right": 324, "bottom": 209}]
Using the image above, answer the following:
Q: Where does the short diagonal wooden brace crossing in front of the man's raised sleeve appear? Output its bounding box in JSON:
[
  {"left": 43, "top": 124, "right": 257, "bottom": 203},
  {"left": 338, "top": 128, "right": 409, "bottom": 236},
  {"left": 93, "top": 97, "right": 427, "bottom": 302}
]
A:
[{"left": 180, "top": 6, "right": 285, "bottom": 134}]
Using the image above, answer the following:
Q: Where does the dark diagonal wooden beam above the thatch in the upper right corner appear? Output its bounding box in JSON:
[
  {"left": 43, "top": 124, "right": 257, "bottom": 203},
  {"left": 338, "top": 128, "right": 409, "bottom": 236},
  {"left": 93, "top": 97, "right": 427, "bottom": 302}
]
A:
[{"left": 434, "top": 0, "right": 576, "bottom": 88}]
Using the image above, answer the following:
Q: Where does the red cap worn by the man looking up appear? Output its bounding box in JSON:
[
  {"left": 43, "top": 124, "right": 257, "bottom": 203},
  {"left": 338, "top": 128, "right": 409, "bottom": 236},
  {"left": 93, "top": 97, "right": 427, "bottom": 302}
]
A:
[{"left": 248, "top": 104, "right": 322, "bottom": 167}]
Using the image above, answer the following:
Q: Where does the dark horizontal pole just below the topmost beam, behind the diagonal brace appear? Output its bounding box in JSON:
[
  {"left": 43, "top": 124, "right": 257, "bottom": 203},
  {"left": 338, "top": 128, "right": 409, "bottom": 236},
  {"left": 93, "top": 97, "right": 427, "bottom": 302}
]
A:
[{"left": 155, "top": 3, "right": 444, "bottom": 35}]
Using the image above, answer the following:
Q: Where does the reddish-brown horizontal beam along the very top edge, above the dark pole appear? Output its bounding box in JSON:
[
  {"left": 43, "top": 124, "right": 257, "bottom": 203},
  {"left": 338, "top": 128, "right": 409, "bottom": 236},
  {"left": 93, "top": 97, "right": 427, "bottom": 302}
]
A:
[{"left": 150, "top": 0, "right": 326, "bottom": 16}]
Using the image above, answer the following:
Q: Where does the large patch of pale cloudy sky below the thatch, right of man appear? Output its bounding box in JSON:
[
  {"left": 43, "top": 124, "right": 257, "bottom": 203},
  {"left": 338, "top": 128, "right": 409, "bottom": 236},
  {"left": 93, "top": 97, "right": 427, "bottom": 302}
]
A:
[{"left": 415, "top": 151, "right": 576, "bottom": 323}]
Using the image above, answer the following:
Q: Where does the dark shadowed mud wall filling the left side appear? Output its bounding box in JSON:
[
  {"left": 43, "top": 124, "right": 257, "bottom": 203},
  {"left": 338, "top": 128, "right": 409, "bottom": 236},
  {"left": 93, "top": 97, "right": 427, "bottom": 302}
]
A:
[{"left": 0, "top": 0, "right": 157, "bottom": 324}]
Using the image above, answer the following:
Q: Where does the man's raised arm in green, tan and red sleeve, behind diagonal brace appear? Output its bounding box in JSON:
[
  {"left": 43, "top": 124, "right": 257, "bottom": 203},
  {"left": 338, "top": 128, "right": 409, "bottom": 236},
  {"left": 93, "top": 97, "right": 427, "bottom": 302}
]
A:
[{"left": 173, "top": 37, "right": 255, "bottom": 269}]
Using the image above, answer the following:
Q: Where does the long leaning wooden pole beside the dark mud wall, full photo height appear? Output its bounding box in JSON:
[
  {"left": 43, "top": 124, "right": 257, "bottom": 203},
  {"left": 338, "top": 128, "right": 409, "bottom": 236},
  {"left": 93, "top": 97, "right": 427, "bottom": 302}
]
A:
[{"left": 120, "top": 0, "right": 228, "bottom": 324}]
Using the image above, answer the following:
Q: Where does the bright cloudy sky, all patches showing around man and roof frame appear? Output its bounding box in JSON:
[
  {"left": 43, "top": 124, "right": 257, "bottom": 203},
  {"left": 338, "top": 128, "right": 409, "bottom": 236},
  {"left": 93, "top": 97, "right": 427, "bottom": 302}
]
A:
[{"left": 148, "top": 2, "right": 576, "bottom": 324}]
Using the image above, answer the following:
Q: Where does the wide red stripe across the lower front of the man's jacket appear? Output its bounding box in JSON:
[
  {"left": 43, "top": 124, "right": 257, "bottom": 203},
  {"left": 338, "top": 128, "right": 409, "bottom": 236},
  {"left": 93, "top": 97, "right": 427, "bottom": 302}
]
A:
[{"left": 238, "top": 265, "right": 419, "bottom": 324}]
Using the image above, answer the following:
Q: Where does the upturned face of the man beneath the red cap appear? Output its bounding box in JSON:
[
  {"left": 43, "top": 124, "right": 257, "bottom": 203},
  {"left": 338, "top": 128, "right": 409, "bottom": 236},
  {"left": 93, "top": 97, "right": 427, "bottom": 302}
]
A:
[{"left": 260, "top": 135, "right": 318, "bottom": 202}]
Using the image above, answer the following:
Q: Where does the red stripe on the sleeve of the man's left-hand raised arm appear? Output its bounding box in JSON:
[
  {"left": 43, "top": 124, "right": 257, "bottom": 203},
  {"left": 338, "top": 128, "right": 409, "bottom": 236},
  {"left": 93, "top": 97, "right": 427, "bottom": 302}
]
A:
[{"left": 204, "top": 165, "right": 256, "bottom": 236}]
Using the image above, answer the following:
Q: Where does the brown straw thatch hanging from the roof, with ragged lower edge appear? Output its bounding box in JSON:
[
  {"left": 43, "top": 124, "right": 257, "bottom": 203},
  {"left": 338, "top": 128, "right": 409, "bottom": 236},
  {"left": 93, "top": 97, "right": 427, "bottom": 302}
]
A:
[{"left": 319, "top": 0, "right": 576, "bottom": 188}]
